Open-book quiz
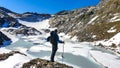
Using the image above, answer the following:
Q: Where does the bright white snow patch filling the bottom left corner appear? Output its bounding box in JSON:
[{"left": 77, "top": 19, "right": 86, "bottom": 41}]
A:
[{"left": 0, "top": 54, "right": 31, "bottom": 68}]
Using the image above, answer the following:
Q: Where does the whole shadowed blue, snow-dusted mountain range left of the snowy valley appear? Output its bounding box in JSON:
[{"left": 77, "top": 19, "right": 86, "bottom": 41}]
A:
[{"left": 0, "top": 7, "right": 51, "bottom": 43}]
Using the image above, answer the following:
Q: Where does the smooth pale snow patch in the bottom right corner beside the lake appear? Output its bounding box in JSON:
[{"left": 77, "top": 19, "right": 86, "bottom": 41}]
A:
[{"left": 90, "top": 51, "right": 120, "bottom": 68}]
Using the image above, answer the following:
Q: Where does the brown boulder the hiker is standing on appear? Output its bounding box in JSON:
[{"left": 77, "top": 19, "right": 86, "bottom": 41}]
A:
[{"left": 22, "top": 58, "right": 73, "bottom": 68}]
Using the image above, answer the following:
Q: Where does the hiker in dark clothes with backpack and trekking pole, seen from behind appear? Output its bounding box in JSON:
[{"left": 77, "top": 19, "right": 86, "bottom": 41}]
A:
[{"left": 47, "top": 29, "right": 64, "bottom": 62}]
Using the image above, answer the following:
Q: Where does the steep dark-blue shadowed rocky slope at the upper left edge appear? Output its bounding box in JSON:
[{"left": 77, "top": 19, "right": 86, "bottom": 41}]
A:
[{"left": 0, "top": 7, "right": 21, "bottom": 28}]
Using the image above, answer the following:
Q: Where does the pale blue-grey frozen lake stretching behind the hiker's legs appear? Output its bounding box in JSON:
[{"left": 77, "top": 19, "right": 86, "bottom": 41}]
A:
[{"left": 6, "top": 39, "right": 105, "bottom": 68}]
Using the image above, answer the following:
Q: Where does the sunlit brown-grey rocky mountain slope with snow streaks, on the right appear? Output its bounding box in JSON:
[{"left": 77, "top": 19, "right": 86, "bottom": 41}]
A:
[{"left": 50, "top": 0, "right": 120, "bottom": 41}]
